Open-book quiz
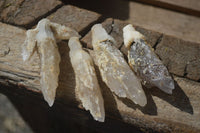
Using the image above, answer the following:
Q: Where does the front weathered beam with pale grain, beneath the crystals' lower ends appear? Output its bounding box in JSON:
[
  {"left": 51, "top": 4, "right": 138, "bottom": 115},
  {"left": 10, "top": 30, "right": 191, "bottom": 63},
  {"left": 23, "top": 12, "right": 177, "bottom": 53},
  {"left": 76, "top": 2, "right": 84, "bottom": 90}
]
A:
[{"left": 0, "top": 19, "right": 200, "bottom": 132}]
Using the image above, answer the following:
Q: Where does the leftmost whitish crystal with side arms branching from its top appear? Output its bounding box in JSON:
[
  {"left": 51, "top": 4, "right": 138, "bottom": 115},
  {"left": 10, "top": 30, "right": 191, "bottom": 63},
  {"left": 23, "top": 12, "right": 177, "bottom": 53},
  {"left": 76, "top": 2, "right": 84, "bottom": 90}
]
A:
[{"left": 22, "top": 19, "right": 79, "bottom": 106}]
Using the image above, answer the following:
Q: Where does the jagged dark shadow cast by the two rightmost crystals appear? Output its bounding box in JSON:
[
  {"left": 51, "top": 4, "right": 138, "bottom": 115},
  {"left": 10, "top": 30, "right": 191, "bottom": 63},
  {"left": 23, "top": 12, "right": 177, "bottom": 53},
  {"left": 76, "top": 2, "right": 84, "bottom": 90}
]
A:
[{"left": 118, "top": 82, "right": 193, "bottom": 115}]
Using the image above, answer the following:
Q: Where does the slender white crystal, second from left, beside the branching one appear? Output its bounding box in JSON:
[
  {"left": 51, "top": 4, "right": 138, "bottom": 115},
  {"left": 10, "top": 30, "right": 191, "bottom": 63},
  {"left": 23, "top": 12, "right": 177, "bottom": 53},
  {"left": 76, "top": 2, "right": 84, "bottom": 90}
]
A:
[{"left": 68, "top": 37, "right": 105, "bottom": 122}]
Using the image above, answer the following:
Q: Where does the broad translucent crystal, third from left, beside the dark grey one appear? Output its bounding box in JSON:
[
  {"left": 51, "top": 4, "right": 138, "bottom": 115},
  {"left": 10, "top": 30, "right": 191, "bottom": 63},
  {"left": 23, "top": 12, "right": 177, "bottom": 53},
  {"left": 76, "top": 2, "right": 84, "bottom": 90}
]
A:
[{"left": 92, "top": 24, "right": 147, "bottom": 106}]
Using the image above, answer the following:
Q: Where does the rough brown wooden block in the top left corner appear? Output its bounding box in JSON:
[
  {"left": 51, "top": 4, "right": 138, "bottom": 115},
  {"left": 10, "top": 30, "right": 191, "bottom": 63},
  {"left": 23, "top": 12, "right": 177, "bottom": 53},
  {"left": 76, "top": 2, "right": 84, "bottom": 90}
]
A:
[{"left": 0, "top": 0, "right": 62, "bottom": 28}]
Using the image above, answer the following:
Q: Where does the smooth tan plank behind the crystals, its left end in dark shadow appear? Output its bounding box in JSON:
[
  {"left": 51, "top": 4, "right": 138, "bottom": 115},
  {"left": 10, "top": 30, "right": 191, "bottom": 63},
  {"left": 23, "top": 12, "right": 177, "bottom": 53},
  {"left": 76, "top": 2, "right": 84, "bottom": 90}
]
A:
[{"left": 59, "top": 0, "right": 200, "bottom": 43}]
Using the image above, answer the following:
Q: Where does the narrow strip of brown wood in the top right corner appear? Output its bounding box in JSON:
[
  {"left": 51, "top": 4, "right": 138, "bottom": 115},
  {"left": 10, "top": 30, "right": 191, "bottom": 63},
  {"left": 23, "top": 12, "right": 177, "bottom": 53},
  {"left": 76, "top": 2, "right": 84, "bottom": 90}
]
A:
[{"left": 135, "top": 0, "right": 200, "bottom": 17}]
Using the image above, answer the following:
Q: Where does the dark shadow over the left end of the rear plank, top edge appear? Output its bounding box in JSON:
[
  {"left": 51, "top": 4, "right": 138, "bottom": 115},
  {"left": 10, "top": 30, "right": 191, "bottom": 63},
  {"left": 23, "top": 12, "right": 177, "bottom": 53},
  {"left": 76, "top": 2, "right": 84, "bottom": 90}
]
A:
[{"left": 62, "top": 0, "right": 129, "bottom": 20}]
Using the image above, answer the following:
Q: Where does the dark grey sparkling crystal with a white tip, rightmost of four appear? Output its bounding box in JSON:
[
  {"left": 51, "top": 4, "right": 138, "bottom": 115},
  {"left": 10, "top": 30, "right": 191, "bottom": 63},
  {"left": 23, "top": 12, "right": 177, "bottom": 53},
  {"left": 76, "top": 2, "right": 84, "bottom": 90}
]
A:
[{"left": 123, "top": 24, "right": 174, "bottom": 94}]
